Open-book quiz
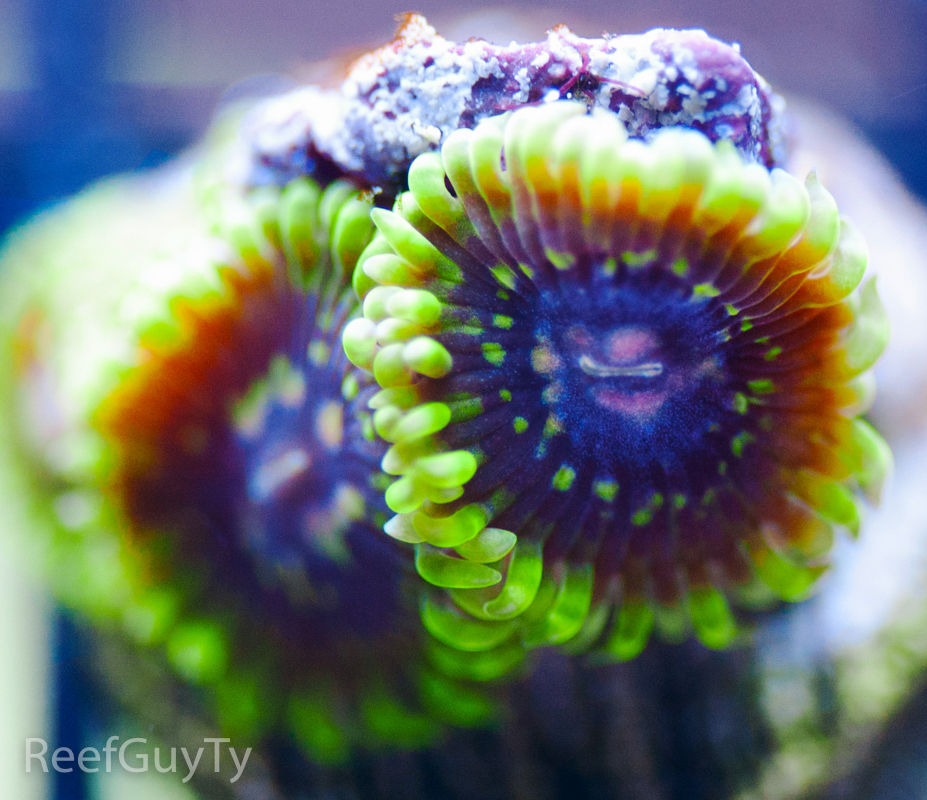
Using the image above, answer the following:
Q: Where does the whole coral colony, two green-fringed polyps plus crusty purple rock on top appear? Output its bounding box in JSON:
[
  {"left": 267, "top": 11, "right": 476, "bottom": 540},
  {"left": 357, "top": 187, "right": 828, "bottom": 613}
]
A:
[{"left": 3, "top": 16, "right": 890, "bottom": 763}]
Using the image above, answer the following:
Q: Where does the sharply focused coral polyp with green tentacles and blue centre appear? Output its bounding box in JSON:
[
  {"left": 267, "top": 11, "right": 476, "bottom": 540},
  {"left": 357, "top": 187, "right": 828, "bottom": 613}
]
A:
[{"left": 344, "top": 102, "right": 888, "bottom": 659}]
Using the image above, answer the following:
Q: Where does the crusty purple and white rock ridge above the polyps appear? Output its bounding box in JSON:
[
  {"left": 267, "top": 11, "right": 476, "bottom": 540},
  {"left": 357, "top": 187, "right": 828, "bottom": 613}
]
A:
[{"left": 241, "top": 14, "right": 784, "bottom": 192}]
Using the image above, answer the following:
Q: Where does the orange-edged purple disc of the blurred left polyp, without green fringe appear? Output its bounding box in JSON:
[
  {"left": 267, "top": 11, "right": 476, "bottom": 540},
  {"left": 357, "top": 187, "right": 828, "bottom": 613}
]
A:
[{"left": 96, "top": 182, "right": 402, "bottom": 663}]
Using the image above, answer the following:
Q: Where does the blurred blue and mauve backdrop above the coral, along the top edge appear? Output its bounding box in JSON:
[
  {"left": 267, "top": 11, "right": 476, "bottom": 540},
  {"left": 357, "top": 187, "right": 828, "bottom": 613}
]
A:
[{"left": 0, "top": 0, "right": 927, "bottom": 227}]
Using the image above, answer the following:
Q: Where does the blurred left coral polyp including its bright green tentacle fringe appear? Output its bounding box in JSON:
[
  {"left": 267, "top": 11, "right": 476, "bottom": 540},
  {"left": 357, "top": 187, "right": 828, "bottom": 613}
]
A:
[{"left": 1, "top": 172, "right": 500, "bottom": 763}]
